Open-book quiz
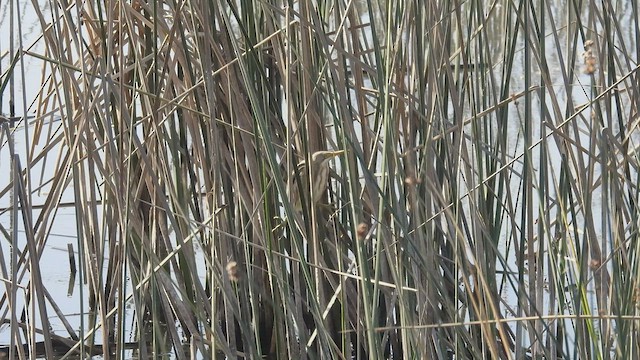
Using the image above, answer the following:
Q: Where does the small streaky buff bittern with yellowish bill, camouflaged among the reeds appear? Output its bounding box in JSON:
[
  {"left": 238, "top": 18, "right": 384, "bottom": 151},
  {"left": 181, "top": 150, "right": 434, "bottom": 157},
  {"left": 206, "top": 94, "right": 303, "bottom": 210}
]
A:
[{"left": 289, "top": 150, "right": 344, "bottom": 211}]
